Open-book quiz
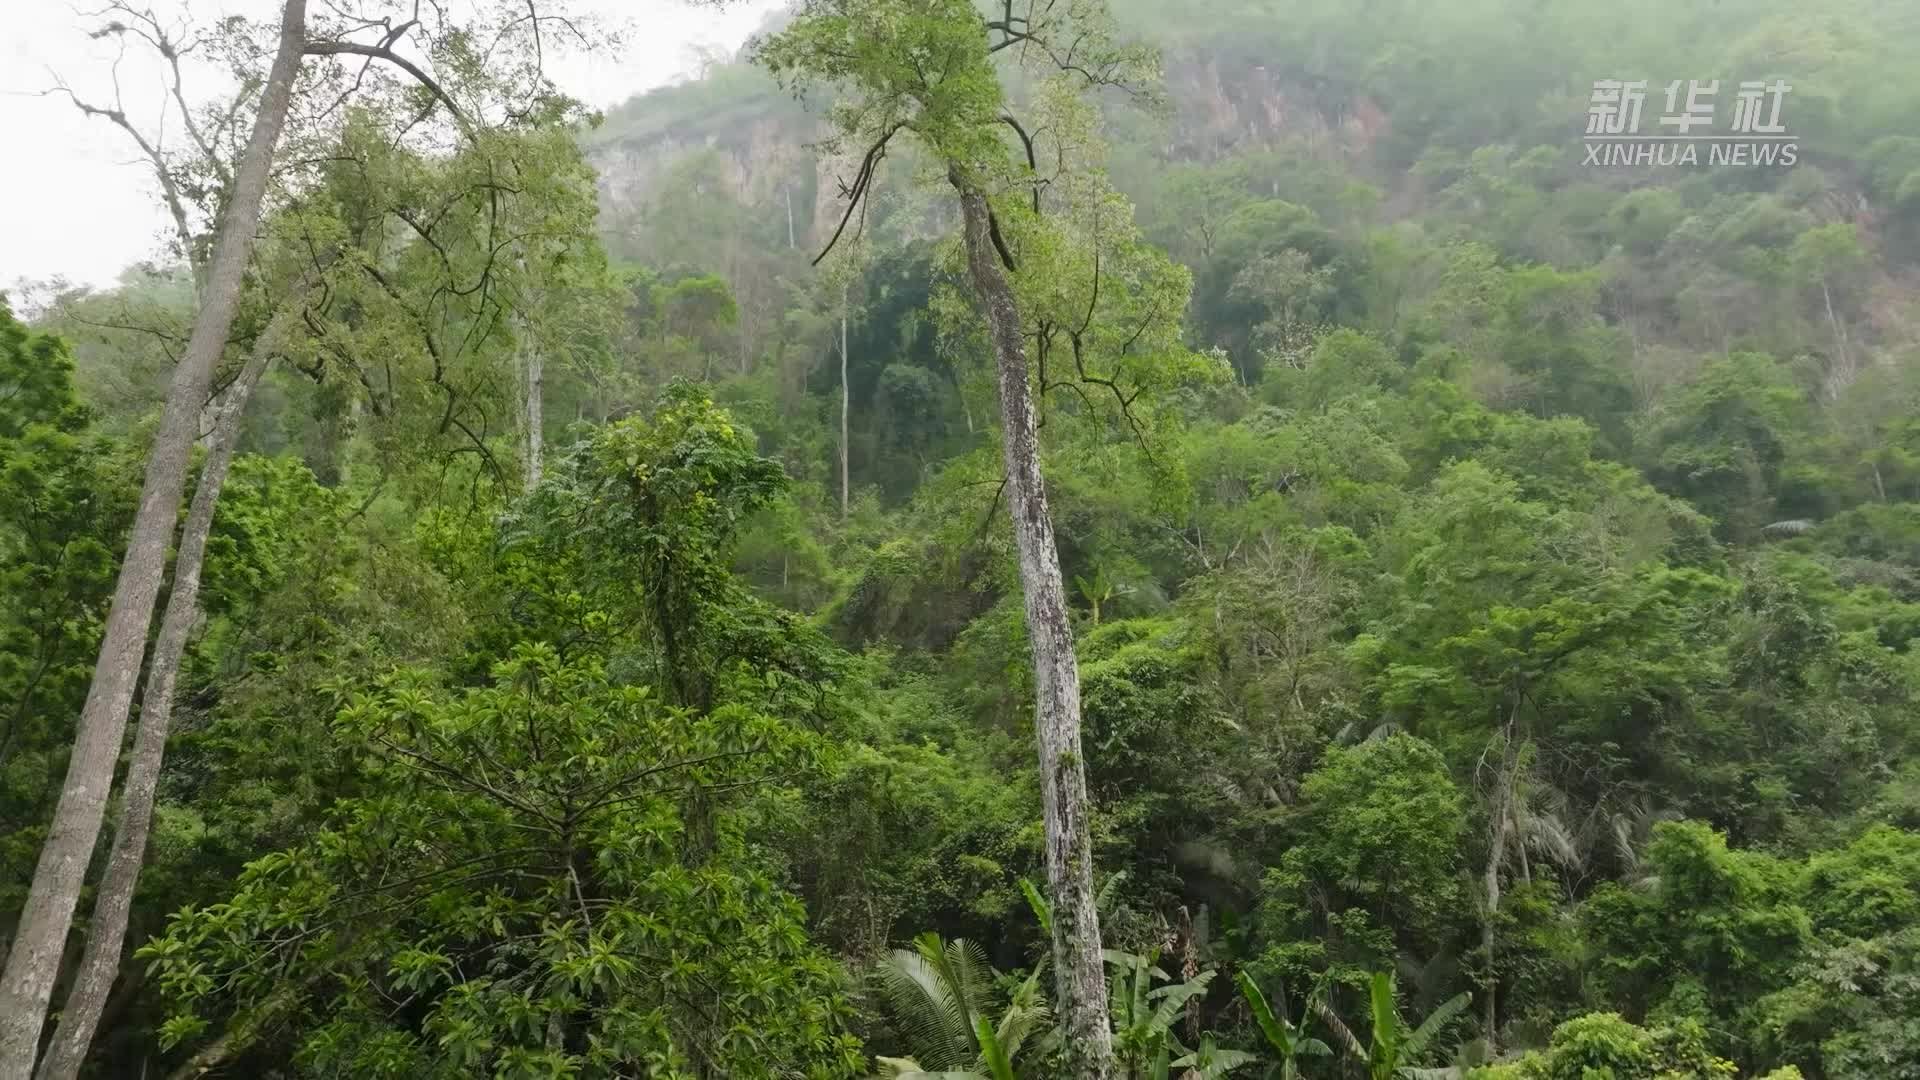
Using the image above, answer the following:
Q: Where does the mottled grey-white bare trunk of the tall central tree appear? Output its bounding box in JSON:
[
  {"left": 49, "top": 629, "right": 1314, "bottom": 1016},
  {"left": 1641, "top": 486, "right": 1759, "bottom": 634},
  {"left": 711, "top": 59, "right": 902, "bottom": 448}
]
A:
[{"left": 952, "top": 171, "right": 1114, "bottom": 1080}]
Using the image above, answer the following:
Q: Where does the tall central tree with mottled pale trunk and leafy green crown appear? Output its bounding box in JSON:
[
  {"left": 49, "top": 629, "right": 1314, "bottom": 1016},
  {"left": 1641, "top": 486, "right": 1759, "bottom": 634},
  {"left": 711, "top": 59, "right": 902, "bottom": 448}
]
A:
[{"left": 760, "top": 0, "right": 1152, "bottom": 1080}]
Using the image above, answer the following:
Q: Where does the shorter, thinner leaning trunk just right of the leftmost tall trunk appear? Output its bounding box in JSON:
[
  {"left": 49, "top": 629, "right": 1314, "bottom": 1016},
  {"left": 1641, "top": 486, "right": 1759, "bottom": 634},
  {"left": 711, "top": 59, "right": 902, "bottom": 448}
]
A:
[{"left": 35, "top": 296, "right": 300, "bottom": 1080}]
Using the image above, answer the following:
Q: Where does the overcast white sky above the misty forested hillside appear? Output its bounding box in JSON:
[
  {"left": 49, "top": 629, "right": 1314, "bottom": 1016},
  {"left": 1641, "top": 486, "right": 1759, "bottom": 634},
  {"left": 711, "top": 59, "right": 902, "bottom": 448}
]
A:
[{"left": 0, "top": 0, "right": 780, "bottom": 288}]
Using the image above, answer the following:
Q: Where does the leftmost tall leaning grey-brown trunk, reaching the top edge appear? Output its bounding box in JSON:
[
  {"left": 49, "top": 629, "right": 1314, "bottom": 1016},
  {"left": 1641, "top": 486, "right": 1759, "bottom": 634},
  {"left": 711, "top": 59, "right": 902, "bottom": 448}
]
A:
[{"left": 0, "top": 0, "right": 307, "bottom": 1080}]
